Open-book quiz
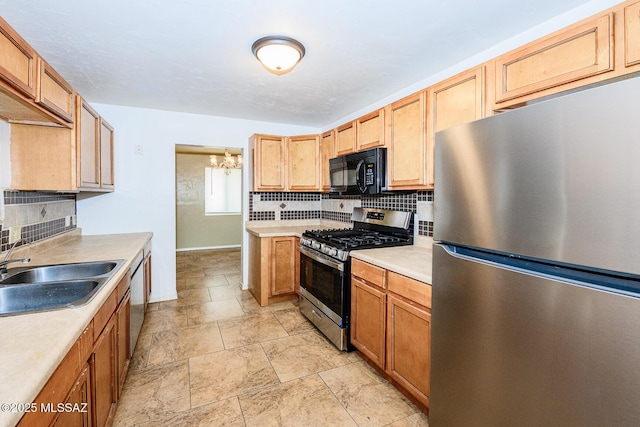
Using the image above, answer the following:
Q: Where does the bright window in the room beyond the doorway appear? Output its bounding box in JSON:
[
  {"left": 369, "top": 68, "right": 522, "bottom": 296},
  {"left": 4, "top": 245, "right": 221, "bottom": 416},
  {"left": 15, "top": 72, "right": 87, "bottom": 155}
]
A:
[{"left": 204, "top": 167, "right": 242, "bottom": 215}]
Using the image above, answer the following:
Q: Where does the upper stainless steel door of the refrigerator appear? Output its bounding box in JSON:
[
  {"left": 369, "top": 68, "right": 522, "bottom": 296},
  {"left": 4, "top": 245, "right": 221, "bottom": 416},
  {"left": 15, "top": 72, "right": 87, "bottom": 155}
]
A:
[{"left": 434, "top": 78, "right": 640, "bottom": 274}]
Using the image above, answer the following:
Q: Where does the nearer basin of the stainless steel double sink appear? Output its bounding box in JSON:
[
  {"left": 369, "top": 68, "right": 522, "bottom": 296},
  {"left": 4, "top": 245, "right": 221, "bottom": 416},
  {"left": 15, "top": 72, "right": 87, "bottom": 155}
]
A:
[{"left": 0, "top": 279, "right": 106, "bottom": 315}]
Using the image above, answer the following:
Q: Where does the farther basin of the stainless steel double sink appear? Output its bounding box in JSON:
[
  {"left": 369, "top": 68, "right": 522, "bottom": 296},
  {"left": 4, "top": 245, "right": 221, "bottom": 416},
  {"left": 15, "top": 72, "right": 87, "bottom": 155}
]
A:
[{"left": 0, "top": 261, "right": 118, "bottom": 285}]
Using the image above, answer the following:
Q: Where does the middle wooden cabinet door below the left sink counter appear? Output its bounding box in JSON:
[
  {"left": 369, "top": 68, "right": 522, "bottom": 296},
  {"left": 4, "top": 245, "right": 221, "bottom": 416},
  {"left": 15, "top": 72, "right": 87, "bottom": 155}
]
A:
[{"left": 91, "top": 315, "right": 118, "bottom": 427}]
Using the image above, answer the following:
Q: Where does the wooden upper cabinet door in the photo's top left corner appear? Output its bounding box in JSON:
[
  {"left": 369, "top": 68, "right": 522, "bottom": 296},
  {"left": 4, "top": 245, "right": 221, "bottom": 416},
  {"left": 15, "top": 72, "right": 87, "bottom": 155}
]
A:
[{"left": 0, "top": 17, "right": 37, "bottom": 99}]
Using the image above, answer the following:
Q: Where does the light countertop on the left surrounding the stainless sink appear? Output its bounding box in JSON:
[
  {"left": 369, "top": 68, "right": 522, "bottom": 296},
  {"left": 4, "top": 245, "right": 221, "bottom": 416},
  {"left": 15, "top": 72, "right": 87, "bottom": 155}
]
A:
[{"left": 0, "top": 233, "right": 152, "bottom": 426}]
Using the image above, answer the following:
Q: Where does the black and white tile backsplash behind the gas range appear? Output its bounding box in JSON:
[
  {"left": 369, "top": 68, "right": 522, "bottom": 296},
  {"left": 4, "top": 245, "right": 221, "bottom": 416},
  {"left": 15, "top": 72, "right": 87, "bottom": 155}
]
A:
[{"left": 249, "top": 191, "right": 433, "bottom": 236}]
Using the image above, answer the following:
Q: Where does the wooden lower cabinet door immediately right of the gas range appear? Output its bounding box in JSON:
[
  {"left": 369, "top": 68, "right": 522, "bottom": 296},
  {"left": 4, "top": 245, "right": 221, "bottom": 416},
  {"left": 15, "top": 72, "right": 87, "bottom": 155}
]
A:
[{"left": 350, "top": 276, "right": 386, "bottom": 369}]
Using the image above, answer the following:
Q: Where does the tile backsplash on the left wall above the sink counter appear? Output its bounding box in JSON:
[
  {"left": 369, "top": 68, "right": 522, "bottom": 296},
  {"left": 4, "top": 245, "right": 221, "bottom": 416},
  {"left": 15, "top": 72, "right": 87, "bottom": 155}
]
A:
[{"left": 0, "top": 190, "right": 76, "bottom": 252}]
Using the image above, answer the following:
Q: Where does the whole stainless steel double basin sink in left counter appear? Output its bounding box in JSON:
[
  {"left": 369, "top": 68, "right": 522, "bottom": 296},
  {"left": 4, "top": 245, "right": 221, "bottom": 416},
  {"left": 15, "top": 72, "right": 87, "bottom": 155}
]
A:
[{"left": 0, "top": 260, "right": 124, "bottom": 316}]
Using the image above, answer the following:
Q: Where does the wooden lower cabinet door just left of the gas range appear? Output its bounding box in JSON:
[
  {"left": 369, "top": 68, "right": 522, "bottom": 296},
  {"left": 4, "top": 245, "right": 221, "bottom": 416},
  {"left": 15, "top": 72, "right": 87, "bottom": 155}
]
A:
[{"left": 269, "top": 237, "right": 299, "bottom": 296}]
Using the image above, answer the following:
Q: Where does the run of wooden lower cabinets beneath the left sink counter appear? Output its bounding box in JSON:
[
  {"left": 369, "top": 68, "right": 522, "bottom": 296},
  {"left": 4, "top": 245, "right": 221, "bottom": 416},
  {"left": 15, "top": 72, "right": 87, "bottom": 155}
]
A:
[{"left": 18, "top": 272, "right": 131, "bottom": 427}]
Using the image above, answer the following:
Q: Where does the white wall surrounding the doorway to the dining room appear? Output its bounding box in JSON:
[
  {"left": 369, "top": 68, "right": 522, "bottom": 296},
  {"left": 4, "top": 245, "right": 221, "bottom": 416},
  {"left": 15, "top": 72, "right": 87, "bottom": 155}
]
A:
[{"left": 77, "top": 103, "right": 320, "bottom": 301}]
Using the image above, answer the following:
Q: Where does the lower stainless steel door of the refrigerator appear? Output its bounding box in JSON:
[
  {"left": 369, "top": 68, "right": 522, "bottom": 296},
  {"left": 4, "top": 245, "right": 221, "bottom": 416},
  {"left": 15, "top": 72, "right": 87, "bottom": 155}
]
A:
[{"left": 429, "top": 245, "right": 640, "bottom": 427}]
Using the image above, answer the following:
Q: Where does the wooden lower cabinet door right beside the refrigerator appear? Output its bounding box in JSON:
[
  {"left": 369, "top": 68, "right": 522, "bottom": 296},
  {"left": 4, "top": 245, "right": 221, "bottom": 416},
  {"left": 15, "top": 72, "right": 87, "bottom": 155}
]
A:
[{"left": 387, "top": 295, "right": 431, "bottom": 406}]
